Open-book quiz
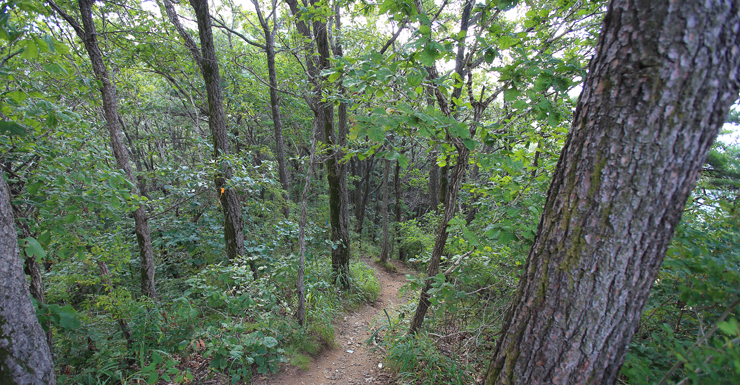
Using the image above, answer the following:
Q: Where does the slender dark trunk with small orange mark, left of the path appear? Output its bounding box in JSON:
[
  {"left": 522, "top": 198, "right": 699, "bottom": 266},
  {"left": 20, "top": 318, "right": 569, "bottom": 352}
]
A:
[{"left": 190, "top": 0, "right": 247, "bottom": 268}]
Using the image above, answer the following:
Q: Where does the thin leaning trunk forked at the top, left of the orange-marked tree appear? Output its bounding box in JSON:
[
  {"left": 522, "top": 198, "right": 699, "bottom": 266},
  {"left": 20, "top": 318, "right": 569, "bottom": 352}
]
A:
[{"left": 49, "top": 0, "right": 157, "bottom": 298}]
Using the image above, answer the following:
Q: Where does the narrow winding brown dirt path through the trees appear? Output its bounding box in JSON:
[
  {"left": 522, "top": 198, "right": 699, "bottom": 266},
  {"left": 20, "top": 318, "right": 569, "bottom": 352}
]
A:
[{"left": 252, "top": 258, "right": 410, "bottom": 385}]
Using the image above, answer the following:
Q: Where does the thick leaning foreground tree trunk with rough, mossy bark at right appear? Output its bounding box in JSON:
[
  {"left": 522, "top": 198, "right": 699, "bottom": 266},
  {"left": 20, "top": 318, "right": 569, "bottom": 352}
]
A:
[{"left": 486, "top": 0, "right": 740, "bottom": 384}]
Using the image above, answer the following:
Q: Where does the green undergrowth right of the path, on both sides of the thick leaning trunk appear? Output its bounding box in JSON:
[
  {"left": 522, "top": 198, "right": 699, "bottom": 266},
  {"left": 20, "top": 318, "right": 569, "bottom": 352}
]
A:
[{"left": 381, "top": 146, "right": 740, "bottom": 384}]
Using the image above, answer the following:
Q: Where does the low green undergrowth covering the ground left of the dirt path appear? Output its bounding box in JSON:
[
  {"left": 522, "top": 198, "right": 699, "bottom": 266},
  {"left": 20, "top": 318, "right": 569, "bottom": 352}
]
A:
[{"left": 39, "top": 224, "right": 380, "bottom": 384}]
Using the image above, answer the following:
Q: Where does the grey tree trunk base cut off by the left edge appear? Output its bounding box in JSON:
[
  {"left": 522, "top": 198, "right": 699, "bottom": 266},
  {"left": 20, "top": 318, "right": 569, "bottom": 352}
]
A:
[{"left": 0, "top": 176, "right": 56, "bottom": 385}]
